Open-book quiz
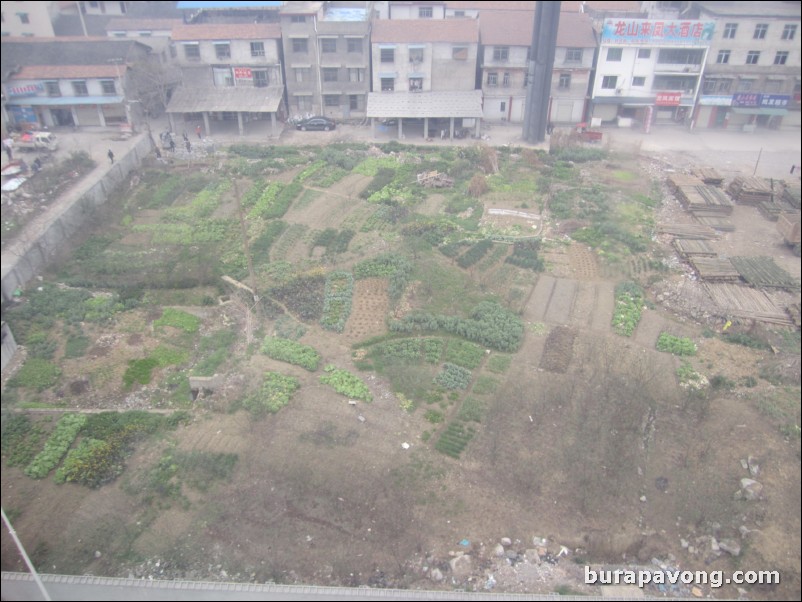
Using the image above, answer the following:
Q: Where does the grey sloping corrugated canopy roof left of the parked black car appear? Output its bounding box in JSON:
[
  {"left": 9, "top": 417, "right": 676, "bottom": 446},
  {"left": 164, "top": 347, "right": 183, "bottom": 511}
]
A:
[{"left": 167, "top": 86, "right": 282, "bottom": 113}]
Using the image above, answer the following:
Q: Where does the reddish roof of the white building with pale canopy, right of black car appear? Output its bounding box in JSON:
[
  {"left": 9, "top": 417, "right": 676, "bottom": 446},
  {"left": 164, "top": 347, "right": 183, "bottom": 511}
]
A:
[{"left": 370, "top": 19, "right": 479, "bottom": 44}]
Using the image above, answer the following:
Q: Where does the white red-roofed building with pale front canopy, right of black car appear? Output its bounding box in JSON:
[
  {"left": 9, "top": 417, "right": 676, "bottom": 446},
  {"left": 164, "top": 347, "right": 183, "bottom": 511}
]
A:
[{"left": 368, "top": 19, "right": 482, "bottom": 137}]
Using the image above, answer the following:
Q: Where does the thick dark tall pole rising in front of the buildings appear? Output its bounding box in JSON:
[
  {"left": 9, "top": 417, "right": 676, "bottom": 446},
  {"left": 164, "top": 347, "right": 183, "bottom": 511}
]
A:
[{"left": 523, "top": 2, "right": 561, "bottom": 142}]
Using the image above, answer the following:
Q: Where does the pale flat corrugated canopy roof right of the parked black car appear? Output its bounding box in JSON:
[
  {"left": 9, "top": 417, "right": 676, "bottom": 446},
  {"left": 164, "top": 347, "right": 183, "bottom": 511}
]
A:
[{"left": 367, "top": 90, "right": 482, "bottom": 119}]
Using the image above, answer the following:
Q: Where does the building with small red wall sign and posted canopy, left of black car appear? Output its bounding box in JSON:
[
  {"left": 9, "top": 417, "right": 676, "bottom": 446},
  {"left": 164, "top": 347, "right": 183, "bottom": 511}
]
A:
[{"left": 167, "top": 23, "right": 284, "bottom": 135}]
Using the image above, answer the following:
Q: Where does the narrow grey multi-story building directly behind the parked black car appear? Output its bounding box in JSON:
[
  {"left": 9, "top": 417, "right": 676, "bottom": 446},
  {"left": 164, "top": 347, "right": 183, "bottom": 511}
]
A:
[{"left": 280, "top": 2, "right": 371, "bottom": 119}]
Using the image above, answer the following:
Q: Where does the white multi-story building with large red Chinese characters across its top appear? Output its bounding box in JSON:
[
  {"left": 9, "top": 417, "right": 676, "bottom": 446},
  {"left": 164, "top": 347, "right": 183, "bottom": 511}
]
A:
[{"left": 592, "top": 18, "right": 715, "bottom": 130}]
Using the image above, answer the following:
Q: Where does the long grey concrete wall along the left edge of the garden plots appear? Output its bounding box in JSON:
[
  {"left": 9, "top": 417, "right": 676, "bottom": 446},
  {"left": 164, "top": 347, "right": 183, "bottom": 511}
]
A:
[{"left": 2, "top": 135, "right": 151, "bottom": 301}]
